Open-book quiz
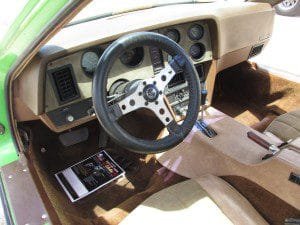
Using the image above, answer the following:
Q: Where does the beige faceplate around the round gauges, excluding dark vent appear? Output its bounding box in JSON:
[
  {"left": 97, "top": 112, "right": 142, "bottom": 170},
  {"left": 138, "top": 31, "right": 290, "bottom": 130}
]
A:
[{"left": 44, "top": 21, "right": 212, "bottom": 112}]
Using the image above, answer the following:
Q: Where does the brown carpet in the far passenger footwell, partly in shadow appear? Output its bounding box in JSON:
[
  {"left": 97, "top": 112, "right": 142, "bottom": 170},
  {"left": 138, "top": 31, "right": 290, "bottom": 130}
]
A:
[{"left": 212, "top": 62, "right": 300, "bottom": 126}]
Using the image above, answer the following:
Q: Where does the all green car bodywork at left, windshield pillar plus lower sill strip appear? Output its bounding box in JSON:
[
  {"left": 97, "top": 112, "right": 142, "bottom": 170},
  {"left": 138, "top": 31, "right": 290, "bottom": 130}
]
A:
[{"left": 0, "top": 0, "right": 78, "bottom": 224}]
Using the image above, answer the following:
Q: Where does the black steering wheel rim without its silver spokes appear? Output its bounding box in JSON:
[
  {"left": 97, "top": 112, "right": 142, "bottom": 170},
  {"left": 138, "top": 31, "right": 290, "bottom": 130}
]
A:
[{"left": 92, "top": 32, "right": 200, "bottom": 154}]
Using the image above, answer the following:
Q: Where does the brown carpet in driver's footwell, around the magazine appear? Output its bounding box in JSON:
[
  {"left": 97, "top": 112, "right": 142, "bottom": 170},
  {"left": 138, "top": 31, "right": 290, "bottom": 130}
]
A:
[{"left": 21, "top": 120, "right": 184, "bottom": 225}]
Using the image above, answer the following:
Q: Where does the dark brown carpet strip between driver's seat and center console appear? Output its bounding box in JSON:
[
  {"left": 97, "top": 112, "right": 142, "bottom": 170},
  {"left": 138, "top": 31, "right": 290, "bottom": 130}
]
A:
[{"left": 222, "top": 176, "right": 300, "bottom": 225}]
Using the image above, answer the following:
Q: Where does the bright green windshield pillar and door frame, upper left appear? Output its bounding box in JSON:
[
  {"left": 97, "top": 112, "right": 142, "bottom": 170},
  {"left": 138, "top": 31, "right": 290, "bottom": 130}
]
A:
[{"left": 0, "top": 0, "right": 70, "bottom": 166}]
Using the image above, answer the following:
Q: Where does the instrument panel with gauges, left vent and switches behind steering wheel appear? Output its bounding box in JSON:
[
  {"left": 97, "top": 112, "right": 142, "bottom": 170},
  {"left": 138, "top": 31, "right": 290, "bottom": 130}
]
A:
[{"left": 44, "top": 21, "right": 212, "bottom": 127}]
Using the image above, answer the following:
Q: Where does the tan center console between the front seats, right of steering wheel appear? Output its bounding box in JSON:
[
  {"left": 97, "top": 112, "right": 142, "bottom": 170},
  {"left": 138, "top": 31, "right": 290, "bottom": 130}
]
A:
[{"left": 156, "top": 107, "right": 300, "bottom": 208}]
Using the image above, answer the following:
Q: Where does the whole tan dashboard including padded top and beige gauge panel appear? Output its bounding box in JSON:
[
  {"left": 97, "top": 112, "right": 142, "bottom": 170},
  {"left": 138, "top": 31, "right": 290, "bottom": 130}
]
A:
[{"left": 14, "top": 3, "right": 274, "bottom": 132}]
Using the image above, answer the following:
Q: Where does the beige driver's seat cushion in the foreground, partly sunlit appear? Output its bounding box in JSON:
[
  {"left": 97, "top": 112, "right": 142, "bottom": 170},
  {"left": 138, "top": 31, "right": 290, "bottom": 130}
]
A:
[{"left": 120, "top": 175, "right": 268, "bottom": 225}]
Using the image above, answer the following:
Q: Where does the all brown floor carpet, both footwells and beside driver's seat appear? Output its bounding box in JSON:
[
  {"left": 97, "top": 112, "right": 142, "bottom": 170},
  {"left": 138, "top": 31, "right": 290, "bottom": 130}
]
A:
[{"left": 20, "top": 60, "right": 300, "bottom": 225}]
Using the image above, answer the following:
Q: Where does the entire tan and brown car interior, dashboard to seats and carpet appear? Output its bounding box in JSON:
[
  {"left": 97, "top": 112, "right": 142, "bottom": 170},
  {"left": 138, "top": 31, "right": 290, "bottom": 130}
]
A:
[{"left": 5, "top": 1, "right": 300, "bottom": 225}]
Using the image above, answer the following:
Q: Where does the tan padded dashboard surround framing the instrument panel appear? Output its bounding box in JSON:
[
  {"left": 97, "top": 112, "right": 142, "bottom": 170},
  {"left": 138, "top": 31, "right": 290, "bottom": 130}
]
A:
[{"left": 14, "top": 2, "right": 274, "bottom": 130}]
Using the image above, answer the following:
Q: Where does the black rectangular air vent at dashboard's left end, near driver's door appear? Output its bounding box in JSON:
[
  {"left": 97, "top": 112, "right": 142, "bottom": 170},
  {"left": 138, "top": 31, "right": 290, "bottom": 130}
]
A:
[{"left": 50, "top": 65, "right": 80, "bottom": 104}]
